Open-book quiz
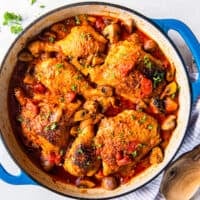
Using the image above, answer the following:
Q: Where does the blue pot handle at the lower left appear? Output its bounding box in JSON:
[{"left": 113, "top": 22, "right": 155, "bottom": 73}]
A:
[{"left": 0, "top": 164, "right": 37, "bottom": 185}]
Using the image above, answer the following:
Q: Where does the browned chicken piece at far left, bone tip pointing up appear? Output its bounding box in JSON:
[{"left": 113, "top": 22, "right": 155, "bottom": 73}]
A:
[{"left": 15, "top": 89, "right": 69, "bottom": 158}]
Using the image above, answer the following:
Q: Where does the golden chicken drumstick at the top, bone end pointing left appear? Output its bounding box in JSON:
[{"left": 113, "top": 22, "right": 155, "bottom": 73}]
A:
[{"left": 28, "top": 25, "right": 107, "bottom": 59}]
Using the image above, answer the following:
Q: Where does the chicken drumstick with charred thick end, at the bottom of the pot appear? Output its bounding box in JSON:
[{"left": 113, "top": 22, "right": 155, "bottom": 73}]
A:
[{"left": 63, "top": 125, "right": 100, "bottom": 176}]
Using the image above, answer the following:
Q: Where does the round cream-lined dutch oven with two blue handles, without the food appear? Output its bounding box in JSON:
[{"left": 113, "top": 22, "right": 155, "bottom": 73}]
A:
[{"left": 0, "top": 2, "right": 200, "bottom": 199}]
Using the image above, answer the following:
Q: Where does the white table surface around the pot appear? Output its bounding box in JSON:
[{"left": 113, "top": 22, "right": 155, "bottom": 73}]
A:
[{"left": 0, "top": 0, "right": 200, "bottom": 200}]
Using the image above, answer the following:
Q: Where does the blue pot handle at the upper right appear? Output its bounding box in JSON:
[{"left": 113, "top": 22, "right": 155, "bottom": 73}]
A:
[{"left": 152, "top": 19, "right": 200, "bottom": 102}]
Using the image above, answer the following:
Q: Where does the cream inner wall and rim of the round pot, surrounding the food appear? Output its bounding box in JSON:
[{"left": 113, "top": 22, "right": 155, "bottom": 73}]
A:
[{"left": 0, "top": 4, "right": 191, "bottom": 199}]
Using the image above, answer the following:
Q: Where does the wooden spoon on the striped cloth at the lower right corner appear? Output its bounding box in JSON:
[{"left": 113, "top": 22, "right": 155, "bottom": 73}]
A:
[{"left": 160, "top": 145, "right": 200, "bottom": 200}]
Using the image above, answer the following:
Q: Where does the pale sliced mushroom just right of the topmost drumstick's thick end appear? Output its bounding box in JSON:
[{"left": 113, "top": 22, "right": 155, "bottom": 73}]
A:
[{"left": 103, "top": 23, "right": 120, "bottom": 43}]
